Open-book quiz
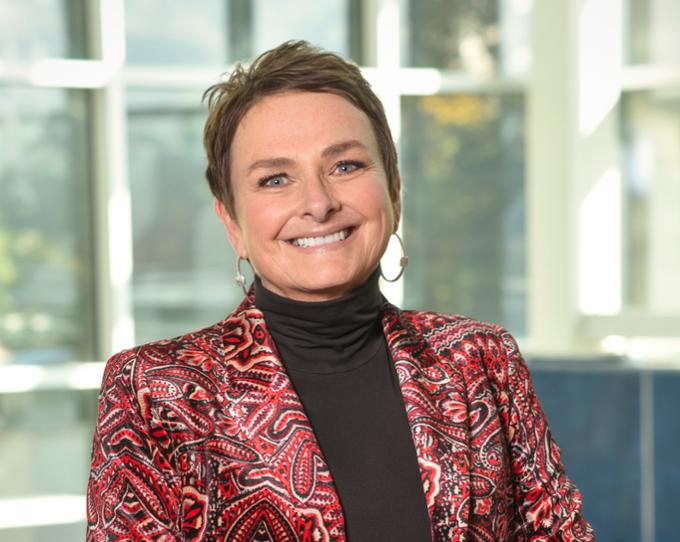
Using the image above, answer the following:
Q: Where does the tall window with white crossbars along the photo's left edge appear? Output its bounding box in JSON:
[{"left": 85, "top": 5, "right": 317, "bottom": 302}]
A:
[{"left": 0, "top": 0, "right": 101, "bottom": 541}]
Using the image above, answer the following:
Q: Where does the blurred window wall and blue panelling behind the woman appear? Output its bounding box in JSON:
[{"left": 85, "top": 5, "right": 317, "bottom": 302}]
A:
[{"left": 0, "top": 0, "right": 680, "bottom": 542}]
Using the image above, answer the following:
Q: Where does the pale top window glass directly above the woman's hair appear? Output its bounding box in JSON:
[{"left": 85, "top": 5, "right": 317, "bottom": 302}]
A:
[{"left": 125, "top": 0, "right": 362, "bottom": 65}]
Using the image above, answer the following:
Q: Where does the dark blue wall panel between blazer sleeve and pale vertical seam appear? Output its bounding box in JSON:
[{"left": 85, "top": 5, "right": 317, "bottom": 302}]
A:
[{"left": 531, "top": 362, "right": 644, "bottom": 542}]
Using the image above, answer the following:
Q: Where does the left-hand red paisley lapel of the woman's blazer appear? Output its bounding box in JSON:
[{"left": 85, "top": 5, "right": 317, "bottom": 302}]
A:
[{"left": 224, "top": 297, "right": 345, "bottom": 542}]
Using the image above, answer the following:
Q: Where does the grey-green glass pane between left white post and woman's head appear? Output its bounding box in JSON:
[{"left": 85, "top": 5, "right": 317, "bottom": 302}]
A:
[{"left": 128, "top": 92, "right": 243, "bottom": 342}]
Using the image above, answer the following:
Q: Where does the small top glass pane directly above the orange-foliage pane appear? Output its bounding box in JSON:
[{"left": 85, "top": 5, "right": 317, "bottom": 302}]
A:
[{"left": 401, "top": 0, "right": 532, "bottom": 76}]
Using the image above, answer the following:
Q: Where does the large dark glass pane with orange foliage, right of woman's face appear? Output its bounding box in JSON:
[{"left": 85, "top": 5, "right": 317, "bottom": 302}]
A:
[{"left": 401, "top": 95, "right": 526, "bottom": 336}]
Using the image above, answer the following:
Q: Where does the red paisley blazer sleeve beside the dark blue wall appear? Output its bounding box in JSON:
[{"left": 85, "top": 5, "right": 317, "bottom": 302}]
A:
[{"left": 490, "top": 328, "right": 595, "bottom": 542}]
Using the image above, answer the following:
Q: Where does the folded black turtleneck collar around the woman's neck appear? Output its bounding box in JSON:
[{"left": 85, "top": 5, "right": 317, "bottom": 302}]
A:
[{"left": 255, "top": 268, "right": 384, "bottom": 373}]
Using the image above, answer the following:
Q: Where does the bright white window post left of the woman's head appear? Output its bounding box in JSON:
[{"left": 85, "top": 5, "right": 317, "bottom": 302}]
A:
[{"left": 92, "top": 0, "right": 135, "bottom": 357}]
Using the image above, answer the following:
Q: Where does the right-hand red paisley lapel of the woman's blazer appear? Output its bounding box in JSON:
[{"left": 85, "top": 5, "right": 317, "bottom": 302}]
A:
[{"left": 383, "top": 304, "right": 471, "bottom": 540}]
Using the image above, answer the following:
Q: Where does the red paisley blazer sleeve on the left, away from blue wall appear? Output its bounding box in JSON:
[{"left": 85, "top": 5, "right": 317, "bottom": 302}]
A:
[{"left": 86, "top": 351, "right": 184, "bottom": 542}]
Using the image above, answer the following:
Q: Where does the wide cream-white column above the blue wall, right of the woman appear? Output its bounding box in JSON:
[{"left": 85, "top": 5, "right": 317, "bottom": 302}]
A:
[{"left": 526, "top": 0, "right": 576, "bottom": 353}]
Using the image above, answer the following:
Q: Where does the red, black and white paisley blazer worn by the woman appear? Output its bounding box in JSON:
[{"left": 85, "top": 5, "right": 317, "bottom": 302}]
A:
[{"left": 87, "top": 298, "right": 594, "bottom": 542}]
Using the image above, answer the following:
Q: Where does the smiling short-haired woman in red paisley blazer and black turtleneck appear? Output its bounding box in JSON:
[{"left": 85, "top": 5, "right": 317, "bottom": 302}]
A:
[{"left": 88, "top": 42, "right": 594, "bottom": 542}]
